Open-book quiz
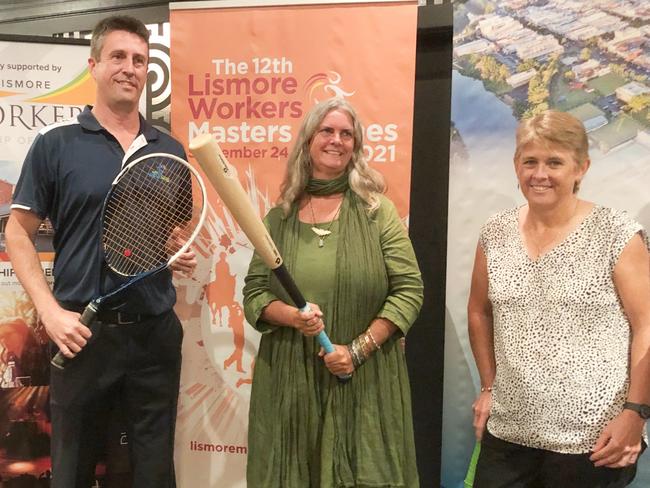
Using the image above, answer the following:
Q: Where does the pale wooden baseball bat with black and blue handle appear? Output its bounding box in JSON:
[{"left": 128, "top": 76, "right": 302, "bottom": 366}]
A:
[{"left": 189, "top": 134, "right": 352, "bottom": 381}]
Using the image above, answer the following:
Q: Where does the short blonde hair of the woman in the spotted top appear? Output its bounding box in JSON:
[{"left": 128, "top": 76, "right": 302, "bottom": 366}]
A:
[{"left": 515, "top": 110, "right": 589, "bottom": 166}]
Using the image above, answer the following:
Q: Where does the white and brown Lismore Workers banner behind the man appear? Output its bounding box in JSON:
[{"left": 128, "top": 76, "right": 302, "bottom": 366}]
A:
[{"left": 0, "top": 37, "right": 95, "bottom": 486}]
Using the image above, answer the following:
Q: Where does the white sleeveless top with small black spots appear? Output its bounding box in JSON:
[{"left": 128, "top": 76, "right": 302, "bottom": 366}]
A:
[{"left": 480, "top": 206, "right": 648, "bottom": 454}]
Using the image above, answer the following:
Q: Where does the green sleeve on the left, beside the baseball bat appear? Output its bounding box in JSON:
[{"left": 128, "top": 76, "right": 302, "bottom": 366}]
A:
[{"left": 243, "top": 215, "right": 279, "bottom": 334}]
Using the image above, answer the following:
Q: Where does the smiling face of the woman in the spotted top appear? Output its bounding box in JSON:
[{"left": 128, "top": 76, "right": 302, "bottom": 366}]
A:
[{"left": 515, "top": 139, "right": 589, "bottom": 207}]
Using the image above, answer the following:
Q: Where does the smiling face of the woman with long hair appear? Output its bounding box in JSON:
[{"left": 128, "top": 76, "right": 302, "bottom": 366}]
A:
[{"left": 309, "top": 109, "right": 354, "bottom": 180}]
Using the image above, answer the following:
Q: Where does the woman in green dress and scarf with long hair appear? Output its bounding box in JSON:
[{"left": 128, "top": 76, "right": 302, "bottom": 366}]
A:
[{"left": 244, "top": 99, "right": 422, "bottom": 488}]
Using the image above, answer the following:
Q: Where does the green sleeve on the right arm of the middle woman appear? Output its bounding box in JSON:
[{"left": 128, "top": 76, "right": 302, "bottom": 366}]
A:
[{"left": 377, "top": 198, "right": 423, "bottom": 334}]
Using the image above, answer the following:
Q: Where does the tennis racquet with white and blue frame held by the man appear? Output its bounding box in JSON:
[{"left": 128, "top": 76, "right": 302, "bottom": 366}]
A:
[{"left": 51, "top": 153, "right": 207, "bottom": 369}]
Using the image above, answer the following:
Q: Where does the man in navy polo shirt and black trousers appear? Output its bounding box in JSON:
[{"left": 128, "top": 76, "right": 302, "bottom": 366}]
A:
[{"left": 6, "top": 16, "right": 196, "bottom": 488}]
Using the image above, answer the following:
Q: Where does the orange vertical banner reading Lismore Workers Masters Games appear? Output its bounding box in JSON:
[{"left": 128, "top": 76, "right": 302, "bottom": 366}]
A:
[{"left": 170, "top": 1, "right": 417, "bottom": 487}]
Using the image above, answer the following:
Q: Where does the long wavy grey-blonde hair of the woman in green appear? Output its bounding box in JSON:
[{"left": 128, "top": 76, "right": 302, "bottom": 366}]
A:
[{"left": 277, "top": 98, "right": 386, "bottom": 215}]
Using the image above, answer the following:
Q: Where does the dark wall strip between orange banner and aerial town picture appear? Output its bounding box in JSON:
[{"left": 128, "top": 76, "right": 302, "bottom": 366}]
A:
[{"left": 406, "top": 2, "right": 452, "bottom": 488}]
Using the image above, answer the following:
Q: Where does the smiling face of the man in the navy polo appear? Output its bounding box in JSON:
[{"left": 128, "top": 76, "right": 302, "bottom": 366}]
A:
[{"left": 88, "top": 30, "right": 149, "bottom": 110}]
